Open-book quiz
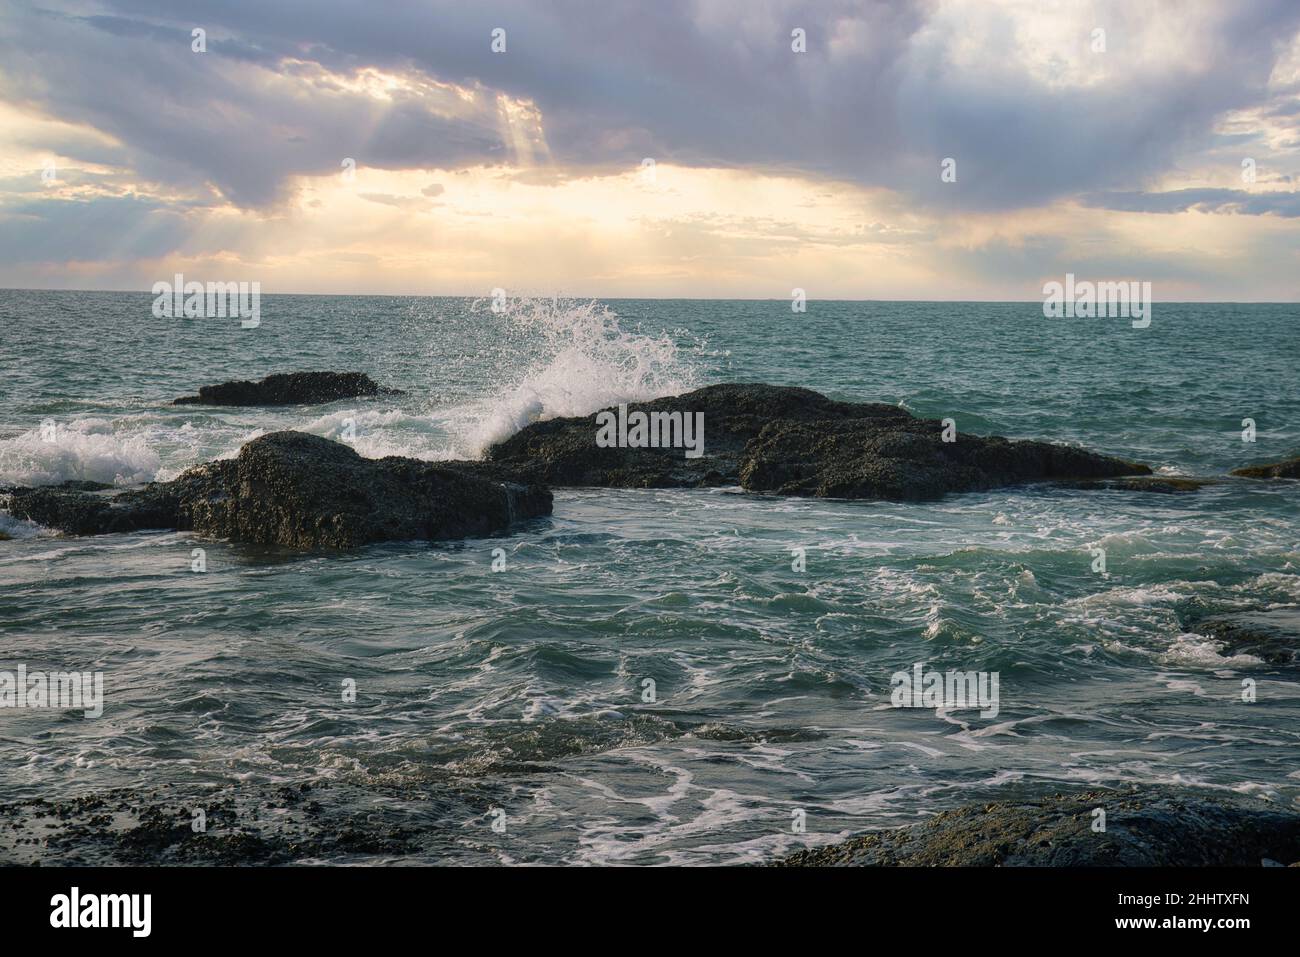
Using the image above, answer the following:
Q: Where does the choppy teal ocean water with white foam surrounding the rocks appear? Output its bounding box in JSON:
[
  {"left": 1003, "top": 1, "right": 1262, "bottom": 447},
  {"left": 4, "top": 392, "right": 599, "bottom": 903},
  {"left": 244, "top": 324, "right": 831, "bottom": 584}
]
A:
[{"left": 0, "top": 291, "right": 1300, "bottom": 865}]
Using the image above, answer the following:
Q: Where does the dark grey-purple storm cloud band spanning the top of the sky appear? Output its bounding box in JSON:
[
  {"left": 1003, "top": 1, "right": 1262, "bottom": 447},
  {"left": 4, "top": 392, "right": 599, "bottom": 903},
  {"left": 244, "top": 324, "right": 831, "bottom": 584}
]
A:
[{"left": 0, "top": 0, "right": 1300, "bottom": 211}]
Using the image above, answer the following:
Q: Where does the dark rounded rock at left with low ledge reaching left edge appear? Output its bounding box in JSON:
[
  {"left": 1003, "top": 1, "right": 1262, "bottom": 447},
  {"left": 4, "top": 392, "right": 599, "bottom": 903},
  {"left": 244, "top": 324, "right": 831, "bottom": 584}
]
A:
[{"left": 8, "top": 432, "right": 551, "bottom": 549}]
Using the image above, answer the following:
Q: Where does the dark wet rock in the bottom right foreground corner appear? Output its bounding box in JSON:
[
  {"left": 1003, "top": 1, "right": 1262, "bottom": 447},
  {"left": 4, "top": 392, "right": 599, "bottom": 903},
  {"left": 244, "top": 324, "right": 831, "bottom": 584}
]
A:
[{"left": 776, "top": 787, "right": 1300, "bottom": 867}]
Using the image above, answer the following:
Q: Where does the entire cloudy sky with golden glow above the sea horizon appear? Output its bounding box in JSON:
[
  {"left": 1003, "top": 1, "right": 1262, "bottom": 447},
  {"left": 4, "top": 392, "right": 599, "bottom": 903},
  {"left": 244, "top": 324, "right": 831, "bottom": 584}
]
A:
[{"left": 0, "top": 0, "right": 1300, "bottom": 302}]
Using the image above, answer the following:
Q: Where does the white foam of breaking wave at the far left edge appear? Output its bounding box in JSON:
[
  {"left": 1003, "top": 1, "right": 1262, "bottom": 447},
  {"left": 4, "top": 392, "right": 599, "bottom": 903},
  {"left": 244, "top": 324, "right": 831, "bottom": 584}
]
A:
[{"left": 0, "top": 419, "right": 161, "bottom": 485}]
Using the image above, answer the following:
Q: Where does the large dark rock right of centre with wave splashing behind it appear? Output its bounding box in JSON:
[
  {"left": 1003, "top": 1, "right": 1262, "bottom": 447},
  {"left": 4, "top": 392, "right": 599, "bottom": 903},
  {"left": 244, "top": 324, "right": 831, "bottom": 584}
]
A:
[{"left": 488, "top": 385, "right": 1151, "bottom": 499}]
